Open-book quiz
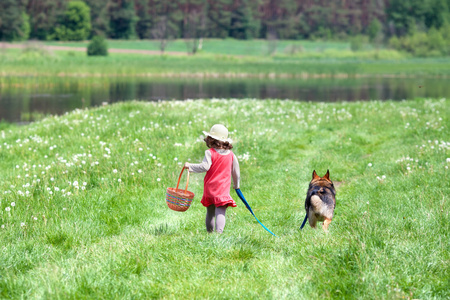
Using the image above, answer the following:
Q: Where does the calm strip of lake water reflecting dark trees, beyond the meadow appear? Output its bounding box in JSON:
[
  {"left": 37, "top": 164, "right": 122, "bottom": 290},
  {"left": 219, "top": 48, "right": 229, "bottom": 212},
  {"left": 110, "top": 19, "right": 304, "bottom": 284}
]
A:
[{"left": 0, "top": 78, "right": 450, "bottom": 123}]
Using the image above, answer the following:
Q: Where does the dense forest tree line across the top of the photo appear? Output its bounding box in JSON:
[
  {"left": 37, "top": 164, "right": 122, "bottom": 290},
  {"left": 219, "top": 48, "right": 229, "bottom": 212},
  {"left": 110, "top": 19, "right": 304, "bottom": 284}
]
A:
[{"left": 0, "top": 0, "right": 450, "bottom": 51}]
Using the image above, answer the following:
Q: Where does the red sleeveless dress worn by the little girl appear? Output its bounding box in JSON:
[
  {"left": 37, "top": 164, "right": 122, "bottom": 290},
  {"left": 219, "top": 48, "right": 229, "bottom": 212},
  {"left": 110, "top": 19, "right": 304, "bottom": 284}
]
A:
[{"left": 201, "top": 148, "right": 236, "bottom": 207}]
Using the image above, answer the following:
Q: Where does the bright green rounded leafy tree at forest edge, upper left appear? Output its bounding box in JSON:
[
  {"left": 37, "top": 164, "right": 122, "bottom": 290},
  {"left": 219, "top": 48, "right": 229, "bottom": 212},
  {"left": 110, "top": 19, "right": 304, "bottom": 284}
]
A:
[{"left": 55, "top": 1, "right": 91, "bottom": 41}]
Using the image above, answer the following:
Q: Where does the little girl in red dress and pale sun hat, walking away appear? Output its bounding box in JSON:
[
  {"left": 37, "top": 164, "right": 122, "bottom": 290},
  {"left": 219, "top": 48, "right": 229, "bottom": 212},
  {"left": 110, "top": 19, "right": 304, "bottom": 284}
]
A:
[{"left": 184, "top": 124, "right": 241, "bottom": 233}]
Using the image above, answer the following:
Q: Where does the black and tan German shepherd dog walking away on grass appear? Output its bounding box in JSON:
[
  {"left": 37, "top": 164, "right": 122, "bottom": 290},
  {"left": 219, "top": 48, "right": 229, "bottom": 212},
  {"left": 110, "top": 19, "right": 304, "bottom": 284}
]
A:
[{"left": 305, "top": 170, "right": 336, "bottom": 231}]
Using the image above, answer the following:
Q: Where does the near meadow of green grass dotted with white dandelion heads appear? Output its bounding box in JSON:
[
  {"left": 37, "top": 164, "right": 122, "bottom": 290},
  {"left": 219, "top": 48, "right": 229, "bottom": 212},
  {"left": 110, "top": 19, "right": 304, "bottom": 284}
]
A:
[{"left": 0, "top": 99, "right": 450, "bottom": 299}]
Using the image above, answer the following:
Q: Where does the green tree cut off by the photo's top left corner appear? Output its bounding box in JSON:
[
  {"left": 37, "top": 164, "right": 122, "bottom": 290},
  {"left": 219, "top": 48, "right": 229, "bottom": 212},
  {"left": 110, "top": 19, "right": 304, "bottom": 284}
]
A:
[{"left": 0, "top": 0, "right": 30, "bottom": 41}]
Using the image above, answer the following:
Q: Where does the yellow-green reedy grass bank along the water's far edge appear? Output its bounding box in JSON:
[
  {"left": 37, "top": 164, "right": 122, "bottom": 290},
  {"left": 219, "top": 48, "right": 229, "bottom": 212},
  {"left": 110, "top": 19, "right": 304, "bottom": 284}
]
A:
[{"left": 0, "top": 42, "right": 450, "bottom": 82}]
